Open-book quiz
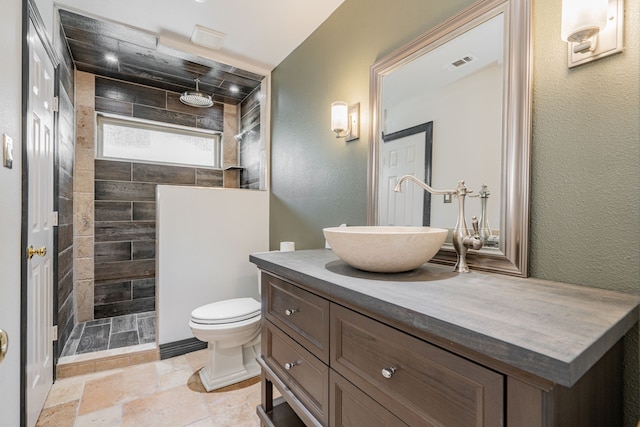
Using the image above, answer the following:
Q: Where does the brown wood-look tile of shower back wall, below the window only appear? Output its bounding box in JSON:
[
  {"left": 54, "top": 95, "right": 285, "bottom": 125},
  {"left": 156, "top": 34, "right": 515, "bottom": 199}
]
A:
[{"left": 94, "top": 160, "right": 222, "bottom": 319}]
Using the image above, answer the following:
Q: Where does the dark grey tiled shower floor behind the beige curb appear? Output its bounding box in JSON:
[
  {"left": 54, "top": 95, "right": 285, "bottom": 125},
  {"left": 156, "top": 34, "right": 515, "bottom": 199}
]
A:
[{"left": 61, "top": 311, "right": 156, "bottom": 357}]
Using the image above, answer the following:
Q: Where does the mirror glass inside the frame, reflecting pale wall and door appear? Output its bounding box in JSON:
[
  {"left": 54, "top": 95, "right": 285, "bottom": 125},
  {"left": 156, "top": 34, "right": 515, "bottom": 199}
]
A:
[{"left": 379, "top": 13, "right": 504, "bottom": 243}]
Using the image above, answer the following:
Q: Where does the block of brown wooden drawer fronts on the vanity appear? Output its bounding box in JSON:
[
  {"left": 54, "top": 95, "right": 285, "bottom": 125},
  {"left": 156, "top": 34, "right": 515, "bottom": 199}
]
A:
[{"left": 262, "top": 273, "right": 504, "bottom": 427}]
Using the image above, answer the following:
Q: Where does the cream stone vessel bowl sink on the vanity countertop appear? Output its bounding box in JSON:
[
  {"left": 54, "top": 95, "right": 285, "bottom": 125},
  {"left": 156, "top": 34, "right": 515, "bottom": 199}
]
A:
[{"left": 322, "top": 226, "right": 448, "bottom": 273}]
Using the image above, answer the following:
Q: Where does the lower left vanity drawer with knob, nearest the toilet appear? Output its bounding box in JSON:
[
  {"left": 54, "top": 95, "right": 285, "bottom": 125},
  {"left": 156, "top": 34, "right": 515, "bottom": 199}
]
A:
[{"left": 262, "top": 321, "right": 329, "bottom": 425}]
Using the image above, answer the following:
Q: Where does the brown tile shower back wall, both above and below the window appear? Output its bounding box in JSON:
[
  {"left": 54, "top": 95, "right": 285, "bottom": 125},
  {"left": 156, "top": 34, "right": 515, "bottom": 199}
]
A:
[{"left": 93, "top": 76, "right": 225, "bottom": 319}]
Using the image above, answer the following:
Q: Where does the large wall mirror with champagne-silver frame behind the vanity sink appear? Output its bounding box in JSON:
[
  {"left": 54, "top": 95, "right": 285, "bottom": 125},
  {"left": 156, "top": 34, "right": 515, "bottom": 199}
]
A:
[{"left": 367, "top": 0, "right": 531, "bottom": 276}]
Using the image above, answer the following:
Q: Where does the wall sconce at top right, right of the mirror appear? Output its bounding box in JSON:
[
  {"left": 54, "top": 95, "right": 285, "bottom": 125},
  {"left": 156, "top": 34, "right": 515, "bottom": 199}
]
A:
[{"left": 560, "top": 0, "right": 624, "bottom": 68}]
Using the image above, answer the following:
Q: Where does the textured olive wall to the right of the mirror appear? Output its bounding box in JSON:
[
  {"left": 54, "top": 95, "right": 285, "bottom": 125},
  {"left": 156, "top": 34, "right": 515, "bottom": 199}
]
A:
[{"left": 530, "top": 0, "right": 640, "bottom": 426}]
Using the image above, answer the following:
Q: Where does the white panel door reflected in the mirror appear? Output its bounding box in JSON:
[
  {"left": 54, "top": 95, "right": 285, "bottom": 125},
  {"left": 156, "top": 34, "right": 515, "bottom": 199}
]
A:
[{"left": 378, "top": 132, "right": 425, "bottom": 226}]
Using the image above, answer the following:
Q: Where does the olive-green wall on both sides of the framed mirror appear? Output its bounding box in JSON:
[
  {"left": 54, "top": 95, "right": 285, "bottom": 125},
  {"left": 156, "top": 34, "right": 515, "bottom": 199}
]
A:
[{"left": 270, "top": 0, "right": 640, "bottom": 427}]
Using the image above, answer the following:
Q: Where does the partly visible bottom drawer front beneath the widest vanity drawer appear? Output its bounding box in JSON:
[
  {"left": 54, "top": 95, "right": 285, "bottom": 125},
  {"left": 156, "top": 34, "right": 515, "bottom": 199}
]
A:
[{"left": 329, "top": 371, "right": 407, "bottom": 427}]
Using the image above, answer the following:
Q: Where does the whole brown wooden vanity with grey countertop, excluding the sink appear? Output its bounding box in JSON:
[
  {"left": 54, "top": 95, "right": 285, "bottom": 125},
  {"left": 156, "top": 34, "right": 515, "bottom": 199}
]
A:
[{"left": 251, "top": 249, "right": 640, "bottom": 427}]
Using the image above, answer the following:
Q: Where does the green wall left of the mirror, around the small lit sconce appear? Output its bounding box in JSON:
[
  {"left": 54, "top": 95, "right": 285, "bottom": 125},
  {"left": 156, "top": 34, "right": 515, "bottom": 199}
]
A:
[{"left": 270, "top": 0, "right": 472, "bottom": 249}]
